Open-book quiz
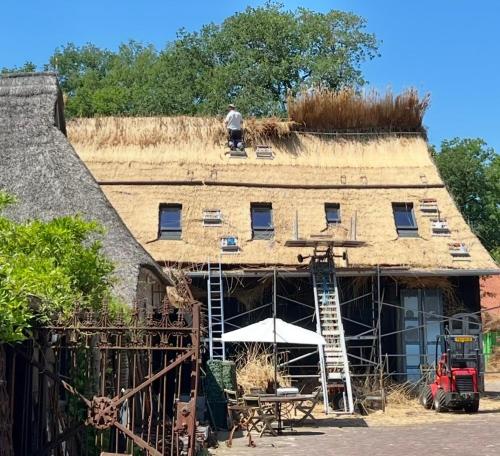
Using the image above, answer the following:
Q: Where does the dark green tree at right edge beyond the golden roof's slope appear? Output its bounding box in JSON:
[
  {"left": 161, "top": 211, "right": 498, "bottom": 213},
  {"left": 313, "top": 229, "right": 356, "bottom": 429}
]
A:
[{"left": 434, "top": 138, "right": 500, "bottom": 261}]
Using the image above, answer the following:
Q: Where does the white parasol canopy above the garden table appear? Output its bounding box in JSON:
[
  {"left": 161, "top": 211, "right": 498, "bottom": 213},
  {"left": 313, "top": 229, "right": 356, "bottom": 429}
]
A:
[{"left": 222, "top": 318, "right": 326, "bottom": 345}]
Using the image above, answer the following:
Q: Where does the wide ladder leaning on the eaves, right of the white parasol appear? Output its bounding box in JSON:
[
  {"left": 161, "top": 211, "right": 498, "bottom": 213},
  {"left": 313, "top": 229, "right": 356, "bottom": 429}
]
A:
[{"left": 311, "top": 248, "right": 354, "bottom": 413}]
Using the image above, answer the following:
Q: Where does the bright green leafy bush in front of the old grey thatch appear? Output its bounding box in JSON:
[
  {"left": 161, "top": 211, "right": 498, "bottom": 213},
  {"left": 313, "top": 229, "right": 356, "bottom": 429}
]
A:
[{"left": 0, "top": 192, "right": 113, "bottom": 342}]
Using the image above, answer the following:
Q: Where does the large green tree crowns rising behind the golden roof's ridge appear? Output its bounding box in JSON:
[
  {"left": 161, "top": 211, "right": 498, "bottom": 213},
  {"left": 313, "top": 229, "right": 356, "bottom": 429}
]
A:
[{"left": 41, "top": 2, "right": 377, "bottom": 117}]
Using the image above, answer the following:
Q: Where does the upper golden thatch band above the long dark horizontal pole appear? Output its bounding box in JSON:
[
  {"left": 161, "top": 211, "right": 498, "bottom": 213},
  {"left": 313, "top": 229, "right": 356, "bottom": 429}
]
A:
[{"left": 68, "top": 117, "right": 442, "bottom": 185}]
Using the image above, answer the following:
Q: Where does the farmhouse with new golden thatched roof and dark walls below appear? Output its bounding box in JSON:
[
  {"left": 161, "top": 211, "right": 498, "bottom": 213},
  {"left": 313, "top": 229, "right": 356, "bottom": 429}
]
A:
[{"left": 69, "top": 108, "right": 498, "bottom": 398}]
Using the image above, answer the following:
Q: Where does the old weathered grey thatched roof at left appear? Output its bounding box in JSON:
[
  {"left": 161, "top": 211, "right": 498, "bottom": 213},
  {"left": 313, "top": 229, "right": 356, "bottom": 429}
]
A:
[{"left": 0, "top": 73, "right": 167, "bottom": 303}]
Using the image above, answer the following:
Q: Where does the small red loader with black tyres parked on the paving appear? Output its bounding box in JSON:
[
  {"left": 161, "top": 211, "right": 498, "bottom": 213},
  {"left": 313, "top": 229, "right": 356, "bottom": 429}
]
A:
[{"left": 420, "top": 335, "right": 481, "bottom": 413}]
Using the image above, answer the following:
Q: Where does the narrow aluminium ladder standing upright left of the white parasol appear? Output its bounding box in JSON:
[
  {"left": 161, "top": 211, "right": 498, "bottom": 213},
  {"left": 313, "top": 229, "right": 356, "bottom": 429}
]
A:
[{"left": 207, "top": 261, "right": 226, "bottom": 361}]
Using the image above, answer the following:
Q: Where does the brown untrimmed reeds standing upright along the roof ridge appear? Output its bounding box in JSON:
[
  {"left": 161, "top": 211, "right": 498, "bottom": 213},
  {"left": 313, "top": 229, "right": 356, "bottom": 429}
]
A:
[{"left": 288, "top": 89, "right": 430, "bottom": 133}]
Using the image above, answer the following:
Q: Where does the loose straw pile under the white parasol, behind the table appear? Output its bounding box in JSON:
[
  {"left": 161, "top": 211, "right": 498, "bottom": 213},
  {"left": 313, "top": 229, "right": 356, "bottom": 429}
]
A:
[{"left": 235, "top": 344, "right": 290, "bottom": 391}]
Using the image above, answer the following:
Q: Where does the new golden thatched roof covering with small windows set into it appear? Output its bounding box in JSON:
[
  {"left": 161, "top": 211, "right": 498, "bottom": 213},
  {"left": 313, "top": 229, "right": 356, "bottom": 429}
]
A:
[{"left": 68, "top": 117, "right": 498, "bottom": 271}]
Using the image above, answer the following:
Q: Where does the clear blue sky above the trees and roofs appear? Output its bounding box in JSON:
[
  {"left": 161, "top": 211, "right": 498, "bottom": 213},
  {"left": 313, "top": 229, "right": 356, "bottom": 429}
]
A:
[{"left": 0, "top": 0, "right": 500, "bottom": 151}]
